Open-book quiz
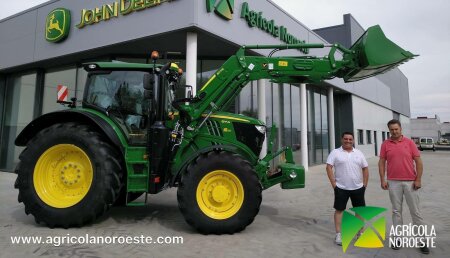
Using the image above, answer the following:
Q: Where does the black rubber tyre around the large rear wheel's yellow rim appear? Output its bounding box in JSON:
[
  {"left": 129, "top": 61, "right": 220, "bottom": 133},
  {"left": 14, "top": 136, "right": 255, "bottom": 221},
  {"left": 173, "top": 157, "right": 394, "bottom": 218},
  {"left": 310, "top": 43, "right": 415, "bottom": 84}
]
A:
[{"left": 15, "top": 123, "right": 123, "bottom": 228}]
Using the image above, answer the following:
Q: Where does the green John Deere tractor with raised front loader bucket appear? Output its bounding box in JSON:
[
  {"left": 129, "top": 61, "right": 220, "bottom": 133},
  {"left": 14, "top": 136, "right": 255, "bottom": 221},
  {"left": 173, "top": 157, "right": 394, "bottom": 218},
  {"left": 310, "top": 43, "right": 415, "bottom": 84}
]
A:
[{"left": 15, "top": 26, "right": 414, "bottom": 234}]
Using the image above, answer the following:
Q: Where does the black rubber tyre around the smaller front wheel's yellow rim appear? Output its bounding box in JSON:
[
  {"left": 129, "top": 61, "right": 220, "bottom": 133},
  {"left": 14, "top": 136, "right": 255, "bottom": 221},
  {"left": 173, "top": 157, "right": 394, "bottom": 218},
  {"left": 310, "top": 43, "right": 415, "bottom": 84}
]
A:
[{"left": 177, "top": 152, "right": 262, "bottom": 234}]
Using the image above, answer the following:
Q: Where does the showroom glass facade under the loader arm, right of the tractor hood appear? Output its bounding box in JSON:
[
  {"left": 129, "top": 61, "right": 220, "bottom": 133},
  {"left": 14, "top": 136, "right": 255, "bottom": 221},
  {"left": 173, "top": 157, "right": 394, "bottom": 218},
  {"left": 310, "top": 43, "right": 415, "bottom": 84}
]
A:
[{"left": 237, "top": 82, "right": 329, "bottom": 164}]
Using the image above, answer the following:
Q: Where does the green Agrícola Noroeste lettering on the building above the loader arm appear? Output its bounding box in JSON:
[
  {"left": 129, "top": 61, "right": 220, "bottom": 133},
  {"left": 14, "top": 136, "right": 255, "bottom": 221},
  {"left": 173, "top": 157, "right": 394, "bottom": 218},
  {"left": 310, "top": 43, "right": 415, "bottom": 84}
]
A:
[{"left": 241, "top": 2, "right": 309, "bottom": 54}]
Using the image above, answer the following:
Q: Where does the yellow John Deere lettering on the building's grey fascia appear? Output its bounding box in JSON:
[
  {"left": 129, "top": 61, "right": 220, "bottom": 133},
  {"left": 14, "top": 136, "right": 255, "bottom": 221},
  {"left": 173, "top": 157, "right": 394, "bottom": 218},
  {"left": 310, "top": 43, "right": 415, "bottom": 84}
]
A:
[{"left": 76, "top": 0, "right": 171, "bottom": 29}]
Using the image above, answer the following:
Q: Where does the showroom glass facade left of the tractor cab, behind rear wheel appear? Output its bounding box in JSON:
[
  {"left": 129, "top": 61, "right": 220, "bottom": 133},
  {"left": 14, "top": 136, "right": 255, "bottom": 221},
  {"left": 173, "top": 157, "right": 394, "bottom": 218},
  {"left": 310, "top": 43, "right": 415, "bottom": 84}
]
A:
[{"left": 0, "top": 66, "right": 98, "bottom": 171}]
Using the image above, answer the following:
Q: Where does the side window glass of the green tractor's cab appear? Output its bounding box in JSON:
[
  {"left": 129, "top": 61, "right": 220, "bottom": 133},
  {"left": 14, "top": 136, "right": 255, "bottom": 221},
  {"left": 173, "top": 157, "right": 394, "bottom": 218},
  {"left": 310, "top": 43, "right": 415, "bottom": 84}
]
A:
[{"left": 83, "top": 71, "right": 150, "bottom": 144}]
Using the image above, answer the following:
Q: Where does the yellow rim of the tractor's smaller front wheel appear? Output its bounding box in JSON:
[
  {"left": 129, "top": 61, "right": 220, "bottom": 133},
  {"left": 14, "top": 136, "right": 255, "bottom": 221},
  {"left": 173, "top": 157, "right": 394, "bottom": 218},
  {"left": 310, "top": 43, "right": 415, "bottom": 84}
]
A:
[{"left": 197, "top": 170, "right": 244, "bottom": 219}]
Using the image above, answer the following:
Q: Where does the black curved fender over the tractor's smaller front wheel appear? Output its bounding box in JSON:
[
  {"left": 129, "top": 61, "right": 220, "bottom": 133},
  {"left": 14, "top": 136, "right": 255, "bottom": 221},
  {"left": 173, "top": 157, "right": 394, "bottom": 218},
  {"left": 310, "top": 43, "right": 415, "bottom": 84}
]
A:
[{"left": 170, "top": 145, "right": 258, "bottom": 186}]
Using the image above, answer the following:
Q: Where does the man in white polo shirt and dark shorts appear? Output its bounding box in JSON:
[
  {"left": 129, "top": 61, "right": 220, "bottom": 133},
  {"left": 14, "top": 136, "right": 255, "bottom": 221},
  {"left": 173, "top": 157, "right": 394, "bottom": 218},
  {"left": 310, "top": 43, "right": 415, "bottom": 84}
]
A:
[{"left": 326, "top": 132, "right": 369, "bottom": 245}]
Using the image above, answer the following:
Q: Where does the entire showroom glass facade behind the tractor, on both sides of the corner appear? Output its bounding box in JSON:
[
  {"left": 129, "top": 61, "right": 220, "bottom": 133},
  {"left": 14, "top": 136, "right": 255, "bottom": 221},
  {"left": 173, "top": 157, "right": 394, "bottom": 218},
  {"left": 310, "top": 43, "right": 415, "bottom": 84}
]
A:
[{"left": 0, "top": 57, "right": 329, "bottom": 171}]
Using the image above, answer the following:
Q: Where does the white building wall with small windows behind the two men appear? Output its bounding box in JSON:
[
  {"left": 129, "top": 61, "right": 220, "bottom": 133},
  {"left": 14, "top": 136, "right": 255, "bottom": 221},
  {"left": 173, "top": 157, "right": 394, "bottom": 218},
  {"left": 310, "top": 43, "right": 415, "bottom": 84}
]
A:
[{"left": 352, "top": 95, "right": 392, "bottom": 158}]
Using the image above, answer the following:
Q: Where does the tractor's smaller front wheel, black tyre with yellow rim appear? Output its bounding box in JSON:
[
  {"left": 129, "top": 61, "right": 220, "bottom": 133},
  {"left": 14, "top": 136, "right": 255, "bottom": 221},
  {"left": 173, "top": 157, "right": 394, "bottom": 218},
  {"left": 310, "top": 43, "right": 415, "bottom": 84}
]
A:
[{"left": 177, "top": 152, "right": 262, "bottom": 234}]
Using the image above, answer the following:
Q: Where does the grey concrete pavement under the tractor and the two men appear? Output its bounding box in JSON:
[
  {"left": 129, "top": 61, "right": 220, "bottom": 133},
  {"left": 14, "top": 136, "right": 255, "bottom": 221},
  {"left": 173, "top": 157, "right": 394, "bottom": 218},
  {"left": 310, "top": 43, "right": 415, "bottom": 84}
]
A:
[{"left": 0, "top": 151, "right": 450, "bottom": 258}]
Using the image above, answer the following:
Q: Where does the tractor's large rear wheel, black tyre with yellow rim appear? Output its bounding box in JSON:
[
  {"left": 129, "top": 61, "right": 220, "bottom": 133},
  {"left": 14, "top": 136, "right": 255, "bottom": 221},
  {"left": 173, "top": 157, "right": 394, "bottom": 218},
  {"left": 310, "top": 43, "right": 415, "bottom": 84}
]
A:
[{"left": 15, "top": 123, "right": 122, "bottom": 228}]
